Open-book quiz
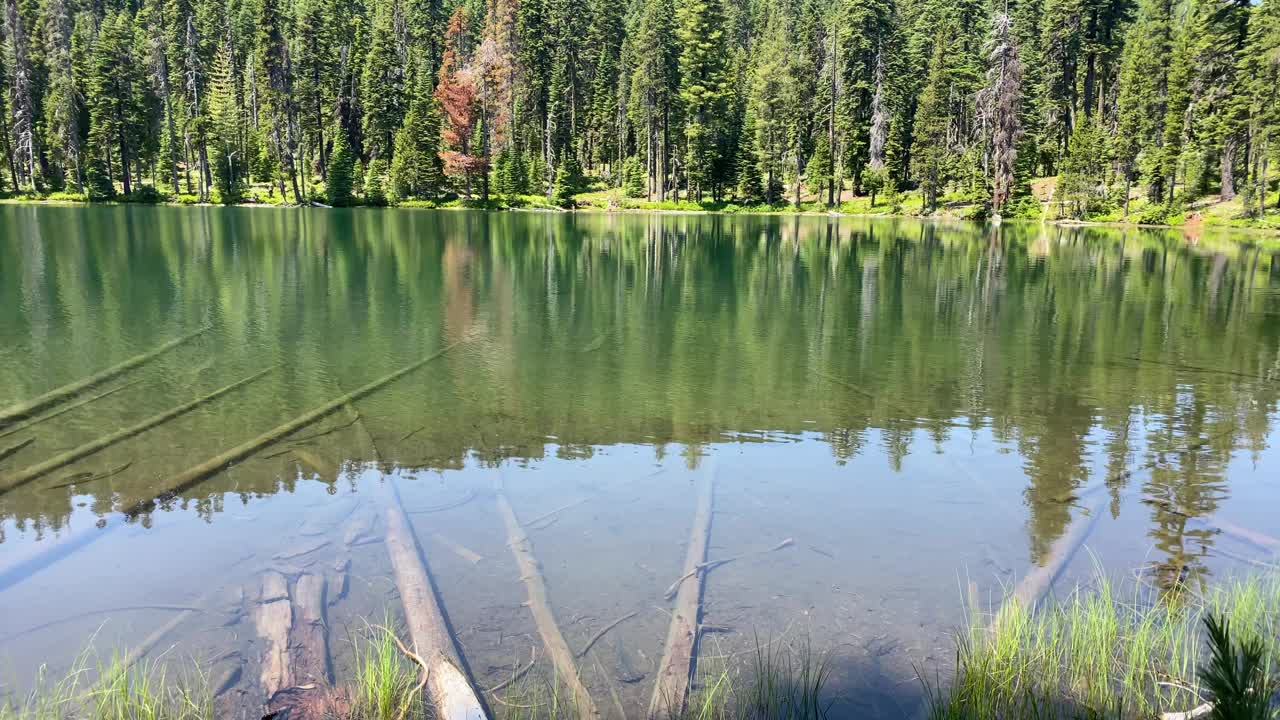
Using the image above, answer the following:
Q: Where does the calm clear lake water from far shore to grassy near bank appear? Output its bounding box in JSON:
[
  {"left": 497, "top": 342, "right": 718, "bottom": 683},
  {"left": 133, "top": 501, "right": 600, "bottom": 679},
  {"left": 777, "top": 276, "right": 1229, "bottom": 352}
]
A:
[{"left": 0, "top": 206, "right": 1280, "bottom": 717}]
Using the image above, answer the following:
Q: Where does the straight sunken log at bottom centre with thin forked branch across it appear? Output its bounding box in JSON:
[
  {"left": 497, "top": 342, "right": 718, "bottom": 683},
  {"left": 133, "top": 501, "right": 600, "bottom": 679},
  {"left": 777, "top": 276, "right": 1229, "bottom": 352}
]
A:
[{"left": 648, "top": 460, "right": 714, "bottom": 720}]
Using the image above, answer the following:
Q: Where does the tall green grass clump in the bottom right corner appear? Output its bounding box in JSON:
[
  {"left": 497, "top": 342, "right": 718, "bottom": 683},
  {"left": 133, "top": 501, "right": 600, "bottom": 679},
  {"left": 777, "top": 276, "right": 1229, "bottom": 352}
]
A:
[{"left": 927, "top": 574, "right": 1280, "bottom": 720}]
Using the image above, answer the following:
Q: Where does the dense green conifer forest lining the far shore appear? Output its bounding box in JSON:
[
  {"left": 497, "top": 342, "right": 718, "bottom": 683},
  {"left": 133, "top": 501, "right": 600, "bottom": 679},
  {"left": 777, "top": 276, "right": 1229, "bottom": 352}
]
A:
[{"left": 0, "top": 0, "right": 1280, "bottom": 222}]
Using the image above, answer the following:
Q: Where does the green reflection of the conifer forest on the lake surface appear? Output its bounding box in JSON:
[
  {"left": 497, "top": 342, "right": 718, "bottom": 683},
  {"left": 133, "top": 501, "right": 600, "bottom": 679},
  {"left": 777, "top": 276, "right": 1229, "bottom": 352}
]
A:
[{"left": 0, "top": 208, "right": 1280, "bottom": 563}]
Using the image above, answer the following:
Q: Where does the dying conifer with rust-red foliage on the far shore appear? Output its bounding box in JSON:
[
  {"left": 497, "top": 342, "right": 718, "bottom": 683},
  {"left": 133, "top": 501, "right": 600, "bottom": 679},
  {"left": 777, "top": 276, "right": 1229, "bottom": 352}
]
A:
[{"left": 434, "top": 6, "right": 488, "bottom": 197}]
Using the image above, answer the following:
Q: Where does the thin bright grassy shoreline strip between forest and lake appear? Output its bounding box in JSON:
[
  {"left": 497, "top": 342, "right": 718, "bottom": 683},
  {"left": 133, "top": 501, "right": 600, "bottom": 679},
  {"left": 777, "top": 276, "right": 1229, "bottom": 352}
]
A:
[{"left": 0, "top": 197, "right": 1280, "bottom": 238}]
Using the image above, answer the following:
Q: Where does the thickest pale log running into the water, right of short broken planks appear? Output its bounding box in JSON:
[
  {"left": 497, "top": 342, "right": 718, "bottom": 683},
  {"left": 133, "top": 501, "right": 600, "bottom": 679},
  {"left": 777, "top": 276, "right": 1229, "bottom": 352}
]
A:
[{"left": 379, "top": 477, "right": 488, "bottom": 720}]
